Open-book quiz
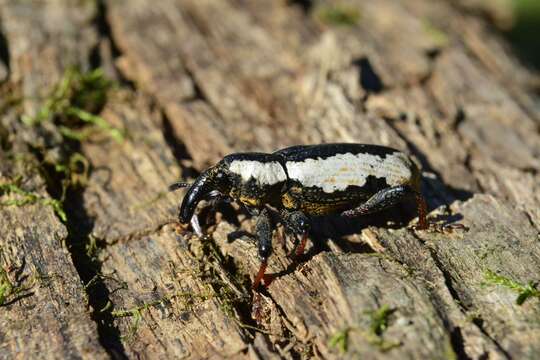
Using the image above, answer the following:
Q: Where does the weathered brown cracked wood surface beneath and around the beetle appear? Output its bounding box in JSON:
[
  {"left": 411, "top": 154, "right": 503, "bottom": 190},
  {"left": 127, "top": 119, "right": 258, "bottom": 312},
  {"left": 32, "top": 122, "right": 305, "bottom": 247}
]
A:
[{"left": 0, "top": 0, "right": 540, "bottom": 359}]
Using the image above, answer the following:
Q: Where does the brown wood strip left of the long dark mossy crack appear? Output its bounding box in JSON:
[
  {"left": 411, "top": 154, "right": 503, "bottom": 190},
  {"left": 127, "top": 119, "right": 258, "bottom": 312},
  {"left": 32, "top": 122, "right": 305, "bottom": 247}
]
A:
[{"left": 0, "top": 1, "right": 107, "bottom": 359}]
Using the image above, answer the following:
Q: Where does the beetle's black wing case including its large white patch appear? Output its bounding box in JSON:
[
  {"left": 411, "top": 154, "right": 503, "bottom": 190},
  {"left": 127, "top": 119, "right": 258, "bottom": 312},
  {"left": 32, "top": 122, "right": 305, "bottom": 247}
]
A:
[{"left": 277, "top": 144, "right": 416, "bottom": 194}]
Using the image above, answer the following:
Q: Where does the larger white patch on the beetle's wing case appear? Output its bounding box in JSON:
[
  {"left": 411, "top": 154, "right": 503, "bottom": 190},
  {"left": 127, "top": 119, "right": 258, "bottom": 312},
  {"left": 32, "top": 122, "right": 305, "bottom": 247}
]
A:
[{"left": 286, "top": 152, "right": 413, "bottom": 193}]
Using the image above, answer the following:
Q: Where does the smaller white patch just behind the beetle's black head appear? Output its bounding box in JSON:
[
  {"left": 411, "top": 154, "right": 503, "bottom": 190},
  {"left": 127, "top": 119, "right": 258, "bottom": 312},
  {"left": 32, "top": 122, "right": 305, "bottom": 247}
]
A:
[{"left": 229, "top": 160, "right": 287, "bottom": 185}]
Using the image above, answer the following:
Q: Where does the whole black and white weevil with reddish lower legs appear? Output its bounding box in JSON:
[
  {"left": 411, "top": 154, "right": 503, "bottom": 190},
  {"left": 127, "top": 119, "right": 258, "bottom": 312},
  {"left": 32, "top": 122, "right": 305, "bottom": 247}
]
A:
[{"left": 171, "top": 144, "right": 446, "bottom": 288}]
